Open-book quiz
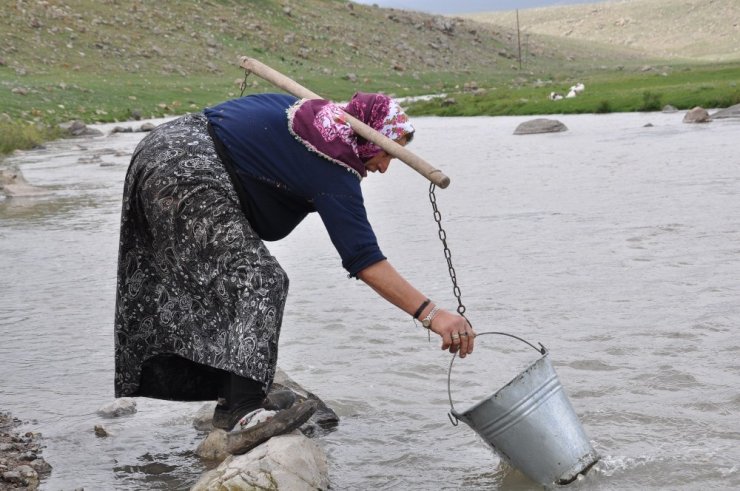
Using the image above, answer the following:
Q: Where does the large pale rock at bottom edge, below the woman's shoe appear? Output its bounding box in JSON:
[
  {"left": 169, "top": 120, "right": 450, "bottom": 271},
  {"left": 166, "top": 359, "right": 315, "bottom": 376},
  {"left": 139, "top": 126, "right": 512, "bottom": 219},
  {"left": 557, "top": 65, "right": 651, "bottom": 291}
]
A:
[{"left": 191, "top": 431, "right": 329, "bottom": 491}]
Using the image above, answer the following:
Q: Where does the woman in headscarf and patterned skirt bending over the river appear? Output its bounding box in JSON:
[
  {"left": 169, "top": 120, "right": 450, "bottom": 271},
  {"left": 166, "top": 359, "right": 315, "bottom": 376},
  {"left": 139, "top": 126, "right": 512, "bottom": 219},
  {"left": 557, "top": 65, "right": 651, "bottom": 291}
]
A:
[{"left": 115, "top": 93, "right": 474, "bottom": 438}]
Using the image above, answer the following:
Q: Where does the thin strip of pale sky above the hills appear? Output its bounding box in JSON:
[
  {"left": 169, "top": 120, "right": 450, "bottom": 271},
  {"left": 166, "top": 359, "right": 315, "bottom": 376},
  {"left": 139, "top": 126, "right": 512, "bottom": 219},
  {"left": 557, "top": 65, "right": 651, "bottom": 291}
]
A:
[{"left": 354, "top": 0, "right": 604, "bottom": 14}]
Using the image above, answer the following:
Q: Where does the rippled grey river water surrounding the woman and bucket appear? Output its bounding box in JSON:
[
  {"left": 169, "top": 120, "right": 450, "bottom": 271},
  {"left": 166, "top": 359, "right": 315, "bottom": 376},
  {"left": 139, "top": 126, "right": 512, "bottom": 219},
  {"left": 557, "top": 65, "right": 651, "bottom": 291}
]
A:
[{"left": 0, "top": 113, "right": 740, "bottom": 490}]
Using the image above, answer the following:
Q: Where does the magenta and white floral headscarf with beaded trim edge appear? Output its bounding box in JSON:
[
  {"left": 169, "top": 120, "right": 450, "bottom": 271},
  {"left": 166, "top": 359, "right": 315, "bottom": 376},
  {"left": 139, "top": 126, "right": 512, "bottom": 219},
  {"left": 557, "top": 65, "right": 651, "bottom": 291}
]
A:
[{"left": 288, "top": 92, "right": 414, "bottom": 177}]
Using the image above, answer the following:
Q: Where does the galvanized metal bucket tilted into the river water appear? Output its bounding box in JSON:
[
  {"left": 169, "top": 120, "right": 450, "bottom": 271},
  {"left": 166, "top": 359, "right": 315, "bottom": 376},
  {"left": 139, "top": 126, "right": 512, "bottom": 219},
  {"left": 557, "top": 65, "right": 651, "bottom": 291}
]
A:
[{"left": 447, "top": 332, "right": 599, "bottom": 486}]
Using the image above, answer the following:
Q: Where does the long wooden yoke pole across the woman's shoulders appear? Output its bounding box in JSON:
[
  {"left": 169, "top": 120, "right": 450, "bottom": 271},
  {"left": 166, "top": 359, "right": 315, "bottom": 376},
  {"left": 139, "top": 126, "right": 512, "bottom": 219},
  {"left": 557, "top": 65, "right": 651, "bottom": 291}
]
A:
[{"left": 239, "top": 56, "right": 450, "bottom": 189}]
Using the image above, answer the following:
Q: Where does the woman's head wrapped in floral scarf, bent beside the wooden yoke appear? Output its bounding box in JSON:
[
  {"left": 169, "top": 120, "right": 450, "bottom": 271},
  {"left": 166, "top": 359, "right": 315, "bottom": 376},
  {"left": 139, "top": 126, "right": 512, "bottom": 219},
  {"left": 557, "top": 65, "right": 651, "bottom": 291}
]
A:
[{"left": 344, "top": 92, "right": 414, "bottom": 161}]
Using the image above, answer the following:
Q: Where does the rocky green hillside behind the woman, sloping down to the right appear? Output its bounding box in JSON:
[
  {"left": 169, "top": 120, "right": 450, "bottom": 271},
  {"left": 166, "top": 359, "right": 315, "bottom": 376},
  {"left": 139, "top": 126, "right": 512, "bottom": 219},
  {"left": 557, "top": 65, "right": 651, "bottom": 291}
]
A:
[{"left": 0, "top": 0, "right": 648, "bottom": 127}]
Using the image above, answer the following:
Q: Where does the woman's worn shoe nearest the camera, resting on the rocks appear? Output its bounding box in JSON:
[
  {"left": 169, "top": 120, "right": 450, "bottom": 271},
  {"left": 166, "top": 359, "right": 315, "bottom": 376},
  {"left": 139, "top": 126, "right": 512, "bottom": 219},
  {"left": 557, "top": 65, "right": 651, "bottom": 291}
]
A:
[{"left": 226, "top": 400, "right": 318, "bottom": 455}]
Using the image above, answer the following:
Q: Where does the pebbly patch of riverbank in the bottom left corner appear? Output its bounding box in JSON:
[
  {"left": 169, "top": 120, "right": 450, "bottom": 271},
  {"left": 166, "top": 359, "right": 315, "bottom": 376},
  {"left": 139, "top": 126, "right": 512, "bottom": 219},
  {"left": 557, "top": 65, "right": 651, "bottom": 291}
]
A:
[{"left": 0, "top": 412, "right": 51, "bottom": 491}]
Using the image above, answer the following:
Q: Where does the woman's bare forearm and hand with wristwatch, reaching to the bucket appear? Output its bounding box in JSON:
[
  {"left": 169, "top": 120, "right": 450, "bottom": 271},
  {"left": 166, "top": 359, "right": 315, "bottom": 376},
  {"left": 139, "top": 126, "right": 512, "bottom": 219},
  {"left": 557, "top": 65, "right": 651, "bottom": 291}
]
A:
[{"left": 357, "top": 260, "right": 475, "bottom": 358}]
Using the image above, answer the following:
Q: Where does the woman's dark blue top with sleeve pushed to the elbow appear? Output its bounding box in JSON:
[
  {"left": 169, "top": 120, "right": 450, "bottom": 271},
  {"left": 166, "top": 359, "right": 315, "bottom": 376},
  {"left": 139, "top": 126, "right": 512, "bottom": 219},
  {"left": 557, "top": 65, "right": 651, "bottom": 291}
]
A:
[{"left": 204, "top": 94, "right": 385, "bottom": 277}]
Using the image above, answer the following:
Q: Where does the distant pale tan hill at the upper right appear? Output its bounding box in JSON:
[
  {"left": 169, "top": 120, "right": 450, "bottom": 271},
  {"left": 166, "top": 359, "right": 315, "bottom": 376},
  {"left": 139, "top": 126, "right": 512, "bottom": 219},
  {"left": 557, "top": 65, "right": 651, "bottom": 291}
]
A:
[{"left": 464, "top": 0, "right": 740, "bottom": 62}]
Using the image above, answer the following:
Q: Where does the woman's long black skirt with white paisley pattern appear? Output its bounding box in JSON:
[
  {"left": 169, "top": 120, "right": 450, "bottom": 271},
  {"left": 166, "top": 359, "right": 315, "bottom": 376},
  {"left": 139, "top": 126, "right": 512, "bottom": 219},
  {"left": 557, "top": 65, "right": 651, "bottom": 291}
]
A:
[{"left": 115, "top": 114, "right": 288, "bottom": 400}]
